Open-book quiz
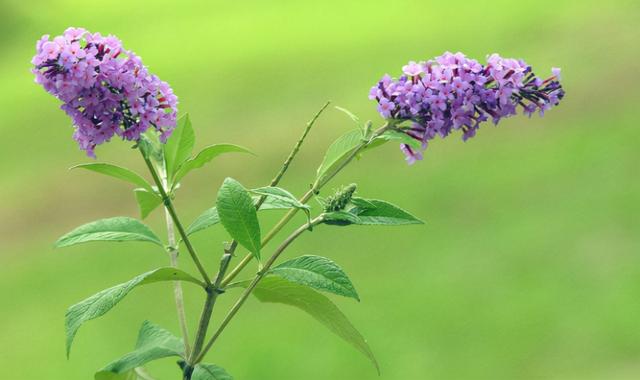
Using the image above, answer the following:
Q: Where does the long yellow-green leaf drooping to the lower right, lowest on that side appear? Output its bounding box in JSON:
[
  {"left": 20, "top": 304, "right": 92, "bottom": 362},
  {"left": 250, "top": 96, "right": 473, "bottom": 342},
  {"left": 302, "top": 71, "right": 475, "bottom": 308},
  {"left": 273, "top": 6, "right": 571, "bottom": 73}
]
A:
[{"left": 253, "top": 276, "right": 380, "bottom": 373}]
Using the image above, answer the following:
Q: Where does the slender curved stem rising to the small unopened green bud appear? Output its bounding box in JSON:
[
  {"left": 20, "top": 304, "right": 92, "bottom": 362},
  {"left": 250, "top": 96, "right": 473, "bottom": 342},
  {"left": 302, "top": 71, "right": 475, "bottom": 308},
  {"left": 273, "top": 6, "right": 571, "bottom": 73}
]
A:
[{"left": 193, "top": 217, "right": 323, "bottom": 363}]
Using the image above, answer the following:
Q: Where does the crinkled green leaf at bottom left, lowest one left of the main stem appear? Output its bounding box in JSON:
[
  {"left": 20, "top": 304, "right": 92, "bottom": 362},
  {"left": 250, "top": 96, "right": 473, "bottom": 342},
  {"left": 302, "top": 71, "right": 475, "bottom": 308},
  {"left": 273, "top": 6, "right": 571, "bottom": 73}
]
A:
[{"left": 95, "top": 321, "right": 184, "bottom": 380}]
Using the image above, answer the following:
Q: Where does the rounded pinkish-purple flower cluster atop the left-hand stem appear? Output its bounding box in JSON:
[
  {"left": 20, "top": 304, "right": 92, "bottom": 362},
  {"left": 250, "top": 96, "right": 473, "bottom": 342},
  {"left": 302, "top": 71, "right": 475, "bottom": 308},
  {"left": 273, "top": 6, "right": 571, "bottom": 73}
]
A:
[{"left": 32, "top": 28, "right": 178, "bottom": 157}]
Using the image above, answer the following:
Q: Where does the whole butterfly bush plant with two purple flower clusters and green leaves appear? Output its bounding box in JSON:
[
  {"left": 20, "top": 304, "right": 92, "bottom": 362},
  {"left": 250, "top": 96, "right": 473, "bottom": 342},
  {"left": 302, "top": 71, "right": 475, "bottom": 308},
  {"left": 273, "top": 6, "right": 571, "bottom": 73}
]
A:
[{"left": 32, "top": 28, "right": 564, "bottom": 380}]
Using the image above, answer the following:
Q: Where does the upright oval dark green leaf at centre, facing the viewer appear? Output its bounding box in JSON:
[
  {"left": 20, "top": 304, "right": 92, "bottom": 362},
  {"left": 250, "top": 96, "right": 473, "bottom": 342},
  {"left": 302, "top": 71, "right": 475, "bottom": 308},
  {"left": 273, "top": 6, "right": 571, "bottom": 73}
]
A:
[{"left": 216, "top": 178, "right": 261, "bottom": 260}]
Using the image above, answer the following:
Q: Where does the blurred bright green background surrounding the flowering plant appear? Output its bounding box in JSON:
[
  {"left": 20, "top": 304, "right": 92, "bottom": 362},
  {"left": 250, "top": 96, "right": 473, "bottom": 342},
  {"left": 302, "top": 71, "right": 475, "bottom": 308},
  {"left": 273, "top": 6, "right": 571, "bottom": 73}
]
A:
[{"left": 0, "top": 0, "right": 640, "bottom": 380}]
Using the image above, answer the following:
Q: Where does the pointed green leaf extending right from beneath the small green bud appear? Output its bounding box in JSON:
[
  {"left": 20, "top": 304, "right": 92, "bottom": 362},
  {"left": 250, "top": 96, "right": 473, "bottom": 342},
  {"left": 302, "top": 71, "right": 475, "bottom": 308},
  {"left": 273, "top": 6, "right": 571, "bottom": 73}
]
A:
[{"left": 323, "top": 198, "right": 424, "bottom": 226}]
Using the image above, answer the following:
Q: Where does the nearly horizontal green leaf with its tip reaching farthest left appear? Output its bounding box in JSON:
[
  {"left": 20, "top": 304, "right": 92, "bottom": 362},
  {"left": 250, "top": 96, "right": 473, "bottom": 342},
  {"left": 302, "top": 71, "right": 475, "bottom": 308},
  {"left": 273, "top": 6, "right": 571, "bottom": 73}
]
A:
[{"left": 54, "top": 216, "right": 163, "bottom": 248}]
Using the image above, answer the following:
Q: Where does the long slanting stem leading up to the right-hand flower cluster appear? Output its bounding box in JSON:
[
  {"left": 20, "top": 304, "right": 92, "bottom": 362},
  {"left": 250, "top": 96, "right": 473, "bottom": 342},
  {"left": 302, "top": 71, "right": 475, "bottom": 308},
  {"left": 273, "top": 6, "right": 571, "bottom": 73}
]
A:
[{"left": 222, "top": 122, "right": 393, "bottom": 288}]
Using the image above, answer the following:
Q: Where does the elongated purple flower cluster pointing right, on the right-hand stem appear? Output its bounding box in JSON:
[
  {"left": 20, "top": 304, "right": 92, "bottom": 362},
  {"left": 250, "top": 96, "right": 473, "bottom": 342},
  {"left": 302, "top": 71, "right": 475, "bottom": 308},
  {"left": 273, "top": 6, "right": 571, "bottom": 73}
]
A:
[{"left": 369, "top": 52, "right": 564, "bottom": 163}]
